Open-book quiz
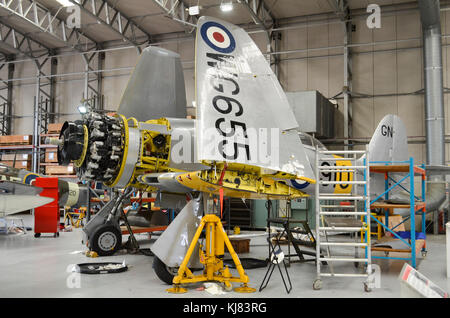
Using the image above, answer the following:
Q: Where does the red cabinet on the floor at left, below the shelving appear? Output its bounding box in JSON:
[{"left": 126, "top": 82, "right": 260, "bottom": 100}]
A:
[{"left": 34, "top": 178, "right": 60, "bottom": 237}]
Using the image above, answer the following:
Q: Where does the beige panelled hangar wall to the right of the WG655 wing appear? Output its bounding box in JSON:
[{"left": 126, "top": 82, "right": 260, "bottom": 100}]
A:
[{"left": 280, "top": 11, "right": 450, "bottom": 163}]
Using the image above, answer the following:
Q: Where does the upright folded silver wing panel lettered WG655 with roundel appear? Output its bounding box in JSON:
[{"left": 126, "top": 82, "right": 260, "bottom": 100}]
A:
[{"left": 195, "top": 16, "right": 315, "bottom": 180}]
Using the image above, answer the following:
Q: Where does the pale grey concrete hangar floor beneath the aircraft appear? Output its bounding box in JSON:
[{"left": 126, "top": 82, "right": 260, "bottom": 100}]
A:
[{"left": 0, "top": 215, "right": 450, "bottom": 298}]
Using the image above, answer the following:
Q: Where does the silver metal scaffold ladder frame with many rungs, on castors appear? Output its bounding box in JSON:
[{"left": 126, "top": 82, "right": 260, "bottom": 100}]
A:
[{"left": 313, "top": 147, "right": 372, "bottom": 292}]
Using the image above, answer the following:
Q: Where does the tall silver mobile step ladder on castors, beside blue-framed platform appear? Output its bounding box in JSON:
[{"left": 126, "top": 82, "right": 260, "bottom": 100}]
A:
[{"left": 313, "top": 148, "right": 372, "bottom": 291}]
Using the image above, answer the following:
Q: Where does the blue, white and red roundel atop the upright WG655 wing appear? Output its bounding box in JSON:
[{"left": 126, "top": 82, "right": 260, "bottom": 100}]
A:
[{"left": 200, "top": 21, "right": 236, "bottom": 54}]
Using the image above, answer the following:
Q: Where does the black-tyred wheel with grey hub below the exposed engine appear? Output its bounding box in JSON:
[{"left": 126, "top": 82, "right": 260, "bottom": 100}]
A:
[{"left": 89, "top": 225, "right": 122, "bottom": 256}]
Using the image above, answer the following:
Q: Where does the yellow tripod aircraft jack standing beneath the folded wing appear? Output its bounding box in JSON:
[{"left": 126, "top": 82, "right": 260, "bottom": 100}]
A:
[{"left": 167, "top": 214, "right": 256, "bottom": 293}]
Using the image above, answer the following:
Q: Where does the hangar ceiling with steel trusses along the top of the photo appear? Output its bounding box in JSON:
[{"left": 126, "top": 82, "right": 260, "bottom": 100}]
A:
[{"left": 0, "top": 0, "right": 440, "bottom": 58}]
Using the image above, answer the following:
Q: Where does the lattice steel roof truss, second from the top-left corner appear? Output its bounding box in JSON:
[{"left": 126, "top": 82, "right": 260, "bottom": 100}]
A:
[{"left": 69, "top": 0, "right": 151, "bottom": 52}]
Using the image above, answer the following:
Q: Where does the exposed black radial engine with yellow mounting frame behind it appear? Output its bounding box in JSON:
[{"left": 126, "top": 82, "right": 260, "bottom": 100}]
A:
[{"left": 57, "top": 112, "right": 194, "bottom": 188}]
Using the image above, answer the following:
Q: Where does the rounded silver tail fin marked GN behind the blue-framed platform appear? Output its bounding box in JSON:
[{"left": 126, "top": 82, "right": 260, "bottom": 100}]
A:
[{"left": 369, "top": 114, "right": 409, "bottom": 162}]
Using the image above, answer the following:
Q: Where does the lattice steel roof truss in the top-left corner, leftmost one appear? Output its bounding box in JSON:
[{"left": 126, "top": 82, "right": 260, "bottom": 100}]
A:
[{"left": 0, "top": 0, "right": 97, "bottom": 52}]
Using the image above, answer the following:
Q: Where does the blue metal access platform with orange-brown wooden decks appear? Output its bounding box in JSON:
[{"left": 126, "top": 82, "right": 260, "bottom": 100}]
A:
[{"left": 370, "top": 157, "right": 426, "bottom": 268}]
